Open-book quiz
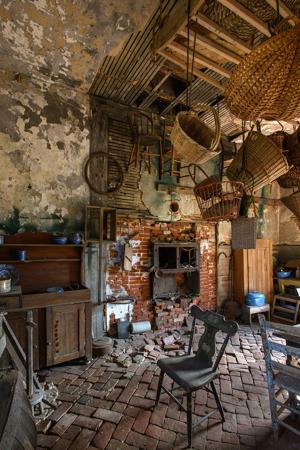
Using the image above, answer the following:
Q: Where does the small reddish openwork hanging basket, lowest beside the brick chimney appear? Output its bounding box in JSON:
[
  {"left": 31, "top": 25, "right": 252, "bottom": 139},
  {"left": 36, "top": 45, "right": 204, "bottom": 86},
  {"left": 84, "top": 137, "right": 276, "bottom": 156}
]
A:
[{"left": 189, "top": 166, "right": 244, "bottom": 222}]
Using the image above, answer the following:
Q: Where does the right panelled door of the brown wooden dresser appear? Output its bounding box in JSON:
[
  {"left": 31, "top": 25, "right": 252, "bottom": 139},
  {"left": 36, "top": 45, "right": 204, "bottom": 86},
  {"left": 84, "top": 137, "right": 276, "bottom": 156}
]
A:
[{"left": 46, "top": 303, "right": 85, "bottom": 365}]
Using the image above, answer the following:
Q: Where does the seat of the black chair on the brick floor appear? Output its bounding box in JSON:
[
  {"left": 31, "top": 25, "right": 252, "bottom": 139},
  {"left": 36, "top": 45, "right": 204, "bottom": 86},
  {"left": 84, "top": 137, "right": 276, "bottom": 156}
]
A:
[{"left": 157, "top": 356, "right": 218, "bottom": 391}]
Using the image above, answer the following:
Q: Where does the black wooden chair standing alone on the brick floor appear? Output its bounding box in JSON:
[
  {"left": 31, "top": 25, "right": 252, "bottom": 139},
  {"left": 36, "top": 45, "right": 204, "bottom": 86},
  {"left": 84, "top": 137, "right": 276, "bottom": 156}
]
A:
[{"left": 156, "top": 305, "right": 238, "bottom": 447}]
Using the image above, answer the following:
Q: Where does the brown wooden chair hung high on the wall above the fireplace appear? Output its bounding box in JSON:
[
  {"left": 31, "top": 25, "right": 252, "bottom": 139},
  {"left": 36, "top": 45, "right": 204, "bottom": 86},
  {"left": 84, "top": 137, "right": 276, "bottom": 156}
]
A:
[{"left": 127, "top": 111, "right": 163, "bottom": 179}]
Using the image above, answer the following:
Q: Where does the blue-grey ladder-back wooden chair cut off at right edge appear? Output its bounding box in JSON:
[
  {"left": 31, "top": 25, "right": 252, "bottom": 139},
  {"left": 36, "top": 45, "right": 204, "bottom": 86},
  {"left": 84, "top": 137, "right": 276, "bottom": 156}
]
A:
[{"left": 258, "top": 314, "right": 300, "bottom": 447}]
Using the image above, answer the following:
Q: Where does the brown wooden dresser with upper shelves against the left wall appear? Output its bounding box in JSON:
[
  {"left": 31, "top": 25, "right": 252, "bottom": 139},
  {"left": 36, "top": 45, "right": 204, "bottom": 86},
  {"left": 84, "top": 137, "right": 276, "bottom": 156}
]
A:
[{"left": 0, "top": 233, "right": 92, "bottom": 369}]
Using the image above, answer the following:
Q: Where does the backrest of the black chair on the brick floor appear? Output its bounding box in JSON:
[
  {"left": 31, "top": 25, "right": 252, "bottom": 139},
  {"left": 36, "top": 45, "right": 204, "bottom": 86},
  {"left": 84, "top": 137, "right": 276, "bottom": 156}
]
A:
[{"left": 188, "top": 305, "right": 238, "bottom": 370}]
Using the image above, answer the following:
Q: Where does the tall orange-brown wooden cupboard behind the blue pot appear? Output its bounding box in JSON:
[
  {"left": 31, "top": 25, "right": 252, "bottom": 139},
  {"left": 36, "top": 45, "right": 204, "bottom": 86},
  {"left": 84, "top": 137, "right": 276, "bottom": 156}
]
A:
[{"left": 233, "top": 239, "right": 273, "bottom": 303}]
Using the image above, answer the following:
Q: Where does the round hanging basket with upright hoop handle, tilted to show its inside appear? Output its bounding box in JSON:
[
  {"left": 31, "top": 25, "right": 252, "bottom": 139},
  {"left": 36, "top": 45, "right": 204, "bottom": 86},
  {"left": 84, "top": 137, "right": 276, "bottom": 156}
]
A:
[{"left": 170, "top": 103, "right": 221, "bottom": 164}]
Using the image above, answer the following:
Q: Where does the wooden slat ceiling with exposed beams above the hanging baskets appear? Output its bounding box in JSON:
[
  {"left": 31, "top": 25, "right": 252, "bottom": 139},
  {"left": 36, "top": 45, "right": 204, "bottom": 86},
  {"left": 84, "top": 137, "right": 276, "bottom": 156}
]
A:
[{"left": 90, "top": 0, "right": 299, "bottom": 134}]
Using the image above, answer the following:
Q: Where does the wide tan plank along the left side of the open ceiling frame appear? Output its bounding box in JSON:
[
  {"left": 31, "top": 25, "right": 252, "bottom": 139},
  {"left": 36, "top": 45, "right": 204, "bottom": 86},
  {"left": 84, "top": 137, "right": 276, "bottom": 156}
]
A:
[{"left": 153, "top": 0, "right": 204, "bottom": 51}]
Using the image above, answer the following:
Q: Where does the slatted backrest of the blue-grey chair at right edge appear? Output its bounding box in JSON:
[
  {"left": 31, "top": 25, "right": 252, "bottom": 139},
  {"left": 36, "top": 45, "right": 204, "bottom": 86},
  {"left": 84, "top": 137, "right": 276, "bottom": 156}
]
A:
[{"left": 258, "top": 314, "right": 300, "bottom": 383}]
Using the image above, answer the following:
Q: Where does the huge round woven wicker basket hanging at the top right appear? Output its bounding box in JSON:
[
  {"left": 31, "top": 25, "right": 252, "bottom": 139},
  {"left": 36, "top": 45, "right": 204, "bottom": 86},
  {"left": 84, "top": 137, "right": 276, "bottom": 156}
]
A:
[{"left": 224, "top": 18, "right": 300, "bottom": 120}]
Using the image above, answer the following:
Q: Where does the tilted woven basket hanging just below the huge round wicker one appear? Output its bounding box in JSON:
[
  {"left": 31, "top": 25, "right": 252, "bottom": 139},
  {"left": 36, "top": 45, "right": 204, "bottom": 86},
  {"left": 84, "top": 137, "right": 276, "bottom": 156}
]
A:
[{"left": 226, "top": 131, "right": 289, "bottom": 193}]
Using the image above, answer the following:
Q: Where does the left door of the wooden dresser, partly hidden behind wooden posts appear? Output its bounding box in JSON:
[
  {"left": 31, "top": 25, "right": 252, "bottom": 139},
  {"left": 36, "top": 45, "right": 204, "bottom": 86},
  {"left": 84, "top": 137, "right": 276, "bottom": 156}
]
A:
[{"left": 7, "top": 309, "right": 39, "bottom": 370}]
